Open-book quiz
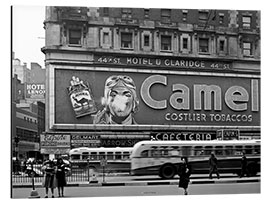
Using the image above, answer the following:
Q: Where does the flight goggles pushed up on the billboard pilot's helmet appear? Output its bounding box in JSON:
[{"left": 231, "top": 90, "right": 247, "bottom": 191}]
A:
[{"left": 105, "top": 75, "right": 136, "bottom": 89}]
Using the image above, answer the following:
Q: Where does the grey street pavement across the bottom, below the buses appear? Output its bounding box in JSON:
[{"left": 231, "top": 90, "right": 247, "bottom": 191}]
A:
[{"left": 11, "top": 174, "right": 260, "bottom": 198}]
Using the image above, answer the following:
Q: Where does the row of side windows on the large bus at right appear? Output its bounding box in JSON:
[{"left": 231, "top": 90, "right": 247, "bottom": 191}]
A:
[{"left": 141, "top": 145, "right": 260, "bottom": 158}]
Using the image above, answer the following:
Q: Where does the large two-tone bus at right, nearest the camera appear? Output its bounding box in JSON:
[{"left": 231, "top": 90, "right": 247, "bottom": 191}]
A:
[{"left": 131, "top": 140, "right": 261, "bottom": 179}]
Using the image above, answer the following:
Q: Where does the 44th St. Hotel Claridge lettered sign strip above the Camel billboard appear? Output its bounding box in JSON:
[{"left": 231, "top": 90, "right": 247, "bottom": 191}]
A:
[{"left": 94, "top": 55, "right": 232, "bottom": 70}]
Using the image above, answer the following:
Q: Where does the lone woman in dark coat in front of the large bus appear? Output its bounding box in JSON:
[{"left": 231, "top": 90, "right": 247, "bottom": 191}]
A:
[{"left": 178, "top": 157, "right": 191, "bottom": 195}]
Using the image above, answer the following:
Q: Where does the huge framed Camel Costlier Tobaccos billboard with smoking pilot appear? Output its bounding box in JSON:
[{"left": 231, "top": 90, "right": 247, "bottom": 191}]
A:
[{"left": 50, "top": 66, "right": 260, "bottom": 127}]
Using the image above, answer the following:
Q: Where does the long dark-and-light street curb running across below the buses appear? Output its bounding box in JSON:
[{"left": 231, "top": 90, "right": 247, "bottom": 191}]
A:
[{"left": 13, "top": 179, "right": 260, "bottom": 188}]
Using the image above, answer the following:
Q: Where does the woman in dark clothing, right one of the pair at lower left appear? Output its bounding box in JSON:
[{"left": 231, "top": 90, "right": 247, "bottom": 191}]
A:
[{"left": 56, "top": 158, "right": 67, "bottom": 197}]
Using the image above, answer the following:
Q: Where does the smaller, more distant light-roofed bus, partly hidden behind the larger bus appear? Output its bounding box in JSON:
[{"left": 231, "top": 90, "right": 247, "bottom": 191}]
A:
[{"left": 69, "top": 147, "right": 132, "bottom": 173}]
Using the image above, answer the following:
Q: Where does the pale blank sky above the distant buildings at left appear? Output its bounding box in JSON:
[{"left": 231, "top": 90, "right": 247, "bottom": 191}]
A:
[{"left": 12, "top": 5, "right": 45, "bottom": 68}]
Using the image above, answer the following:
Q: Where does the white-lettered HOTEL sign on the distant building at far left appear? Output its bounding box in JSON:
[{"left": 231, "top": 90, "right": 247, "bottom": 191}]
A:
[{"left": 25, "top": 83, "right": 45, "bottom": 99}]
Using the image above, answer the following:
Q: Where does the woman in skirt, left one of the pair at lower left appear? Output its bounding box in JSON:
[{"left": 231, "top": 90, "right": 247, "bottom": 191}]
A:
[{"left": 43, "top": 160, "right": 56, "bottom": 198}]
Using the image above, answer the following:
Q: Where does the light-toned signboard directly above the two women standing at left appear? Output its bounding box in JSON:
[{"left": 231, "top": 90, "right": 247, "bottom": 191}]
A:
[{"left": 40, "top": 133, "right": 70, "bottom": 154}]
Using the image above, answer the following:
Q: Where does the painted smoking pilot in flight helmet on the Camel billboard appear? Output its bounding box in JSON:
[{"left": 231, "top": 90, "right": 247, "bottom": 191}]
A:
[{"left": 94, "top": 75, "right": 139, "bottom": 125}]
